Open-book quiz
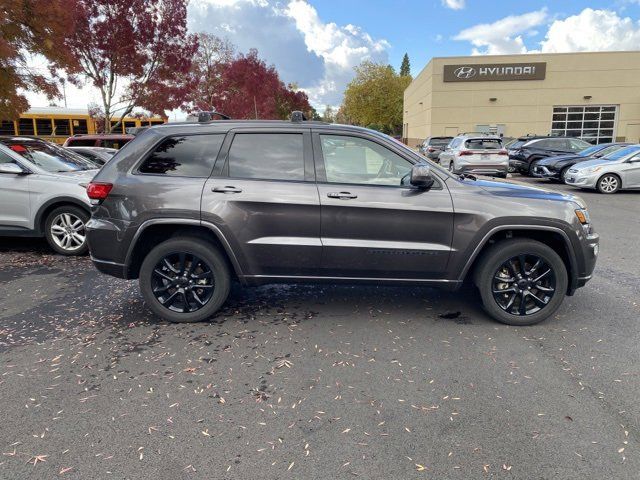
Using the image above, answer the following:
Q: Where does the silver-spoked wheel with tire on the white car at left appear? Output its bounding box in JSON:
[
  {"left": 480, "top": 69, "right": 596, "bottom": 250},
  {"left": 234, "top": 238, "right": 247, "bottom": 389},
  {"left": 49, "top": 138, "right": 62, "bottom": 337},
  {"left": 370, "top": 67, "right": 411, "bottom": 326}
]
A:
[{"left": 44, "top": 205, "right": 90, "bottom": 256}]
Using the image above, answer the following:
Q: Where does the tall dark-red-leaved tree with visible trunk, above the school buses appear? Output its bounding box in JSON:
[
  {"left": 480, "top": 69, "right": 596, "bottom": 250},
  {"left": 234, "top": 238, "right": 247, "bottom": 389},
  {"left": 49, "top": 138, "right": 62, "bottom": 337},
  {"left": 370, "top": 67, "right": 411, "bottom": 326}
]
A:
[{"left": 66, "top": 0, "right": 198, "bottom": 132}]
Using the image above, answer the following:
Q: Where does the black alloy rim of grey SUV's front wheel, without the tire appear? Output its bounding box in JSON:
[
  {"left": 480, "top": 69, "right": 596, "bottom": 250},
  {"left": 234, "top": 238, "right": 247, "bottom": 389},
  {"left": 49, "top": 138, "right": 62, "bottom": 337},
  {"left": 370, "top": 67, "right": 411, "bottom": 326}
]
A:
[{"left": 492, "top": 254, "right": 556, "bottom": 316}]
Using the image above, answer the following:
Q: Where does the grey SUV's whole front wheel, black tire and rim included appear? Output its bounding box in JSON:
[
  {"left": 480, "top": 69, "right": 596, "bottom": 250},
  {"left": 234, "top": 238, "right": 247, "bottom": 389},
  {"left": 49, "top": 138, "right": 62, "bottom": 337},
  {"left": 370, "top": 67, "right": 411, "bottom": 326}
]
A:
[{"left": 475, "top": 239, "right": 569, "bottom": 326}]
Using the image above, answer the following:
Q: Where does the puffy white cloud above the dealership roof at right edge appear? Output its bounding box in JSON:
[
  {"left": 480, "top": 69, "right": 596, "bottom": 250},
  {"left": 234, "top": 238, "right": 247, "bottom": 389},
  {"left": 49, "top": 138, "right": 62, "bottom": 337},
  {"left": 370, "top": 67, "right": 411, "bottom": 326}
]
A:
[{"left": 540, "top": 8, "right": 640, "bottom": 52}]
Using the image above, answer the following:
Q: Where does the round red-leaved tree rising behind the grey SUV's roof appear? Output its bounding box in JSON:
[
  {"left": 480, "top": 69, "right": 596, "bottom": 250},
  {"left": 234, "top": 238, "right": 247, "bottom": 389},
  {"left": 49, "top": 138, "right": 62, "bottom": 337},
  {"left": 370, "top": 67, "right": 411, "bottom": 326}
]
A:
[{"left": 187, "top": 47, "right": 311, "bottom": 119}]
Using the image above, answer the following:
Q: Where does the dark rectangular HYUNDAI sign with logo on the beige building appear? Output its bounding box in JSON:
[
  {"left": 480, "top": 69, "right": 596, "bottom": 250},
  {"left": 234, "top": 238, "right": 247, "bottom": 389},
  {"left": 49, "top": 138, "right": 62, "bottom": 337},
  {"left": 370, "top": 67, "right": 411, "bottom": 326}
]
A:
[{"left": 443, "top": 62, "right": 547, "bottom": 82}]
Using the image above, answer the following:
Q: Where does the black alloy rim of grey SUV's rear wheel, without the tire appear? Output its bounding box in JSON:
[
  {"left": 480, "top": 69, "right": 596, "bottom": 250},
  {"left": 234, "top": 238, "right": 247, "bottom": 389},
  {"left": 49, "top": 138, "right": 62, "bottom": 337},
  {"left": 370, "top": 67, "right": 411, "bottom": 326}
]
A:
[{"left": 151, "top": 252, "right": 215, "bottom": 313}]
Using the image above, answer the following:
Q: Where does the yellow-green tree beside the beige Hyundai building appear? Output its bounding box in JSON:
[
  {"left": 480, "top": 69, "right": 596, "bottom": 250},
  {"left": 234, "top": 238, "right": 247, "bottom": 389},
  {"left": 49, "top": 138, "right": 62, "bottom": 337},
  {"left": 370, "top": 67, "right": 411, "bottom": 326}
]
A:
[{"left": 343, "top": 61, "right": 411, "bottom": 134}]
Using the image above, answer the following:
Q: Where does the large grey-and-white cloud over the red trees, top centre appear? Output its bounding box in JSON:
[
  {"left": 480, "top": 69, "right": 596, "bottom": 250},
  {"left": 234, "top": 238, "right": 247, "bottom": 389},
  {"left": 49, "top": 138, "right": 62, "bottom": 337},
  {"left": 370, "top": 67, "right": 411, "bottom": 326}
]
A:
[{"left": 189, "top": 0, "right": 389, "bottom": 108}]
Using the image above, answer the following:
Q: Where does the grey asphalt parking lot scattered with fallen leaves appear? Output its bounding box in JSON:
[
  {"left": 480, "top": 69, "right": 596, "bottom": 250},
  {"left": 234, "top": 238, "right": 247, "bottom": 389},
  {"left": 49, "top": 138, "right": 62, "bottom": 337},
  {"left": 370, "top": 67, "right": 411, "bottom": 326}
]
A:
[{"left": 0, "top": 180, "right": 640, "bottom": 479}]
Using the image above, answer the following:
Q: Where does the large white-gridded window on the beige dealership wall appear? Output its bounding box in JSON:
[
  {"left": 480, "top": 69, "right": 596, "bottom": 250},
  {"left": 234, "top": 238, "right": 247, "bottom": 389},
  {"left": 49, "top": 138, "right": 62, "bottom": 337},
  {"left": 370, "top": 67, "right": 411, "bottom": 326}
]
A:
[{"left": 551, "top": 105, "right": 617, "bottom": 144}]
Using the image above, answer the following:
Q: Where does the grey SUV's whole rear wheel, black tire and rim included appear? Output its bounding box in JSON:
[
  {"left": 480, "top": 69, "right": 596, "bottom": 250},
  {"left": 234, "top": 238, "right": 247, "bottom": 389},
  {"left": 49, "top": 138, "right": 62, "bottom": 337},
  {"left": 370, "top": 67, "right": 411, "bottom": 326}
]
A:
[{"left": 139, "top": 237, "right": 231, "bottom": 323}]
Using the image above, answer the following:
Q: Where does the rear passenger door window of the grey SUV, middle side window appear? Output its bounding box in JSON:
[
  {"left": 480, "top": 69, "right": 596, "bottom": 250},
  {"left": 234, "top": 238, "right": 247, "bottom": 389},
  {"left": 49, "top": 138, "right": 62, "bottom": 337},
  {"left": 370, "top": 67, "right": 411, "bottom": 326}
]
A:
[{"left": 229, "top": 133, "right": 304, "bottom": 180}]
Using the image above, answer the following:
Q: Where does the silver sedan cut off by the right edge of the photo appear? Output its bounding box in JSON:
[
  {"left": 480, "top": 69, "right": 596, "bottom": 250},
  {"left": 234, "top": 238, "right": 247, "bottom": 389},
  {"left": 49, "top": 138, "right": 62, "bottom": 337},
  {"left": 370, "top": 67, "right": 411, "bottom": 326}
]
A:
[{"left": 566, "top": 145, "right": 640, "bottom": 193}]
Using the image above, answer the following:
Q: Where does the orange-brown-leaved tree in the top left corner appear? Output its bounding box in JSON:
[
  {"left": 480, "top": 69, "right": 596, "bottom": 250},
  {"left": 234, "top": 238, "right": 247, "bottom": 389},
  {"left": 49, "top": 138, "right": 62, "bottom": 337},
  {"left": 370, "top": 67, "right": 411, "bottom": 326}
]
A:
[{"left": 0, "top": 0, "right": 77, "bottom": 119}]
